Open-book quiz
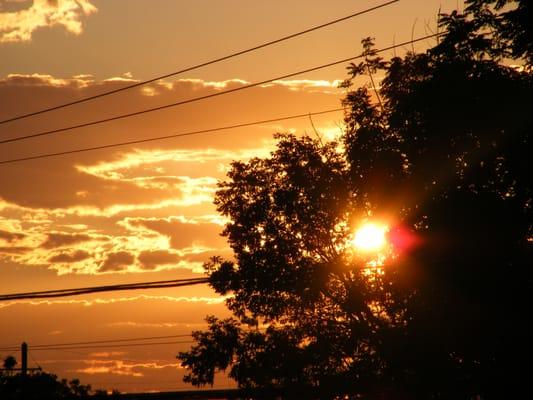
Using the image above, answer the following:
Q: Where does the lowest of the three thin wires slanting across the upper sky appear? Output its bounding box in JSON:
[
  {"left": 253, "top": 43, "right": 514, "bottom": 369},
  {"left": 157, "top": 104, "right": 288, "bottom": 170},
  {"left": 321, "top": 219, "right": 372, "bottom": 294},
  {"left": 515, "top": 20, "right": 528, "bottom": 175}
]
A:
[{"left": 0, "top": 108, "right": 343, "bottom": 165}]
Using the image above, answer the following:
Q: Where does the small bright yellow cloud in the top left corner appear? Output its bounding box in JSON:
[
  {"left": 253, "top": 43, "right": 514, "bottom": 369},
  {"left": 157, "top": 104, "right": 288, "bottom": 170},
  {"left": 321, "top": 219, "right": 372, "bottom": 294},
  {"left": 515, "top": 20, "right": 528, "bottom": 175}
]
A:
[{"left": 0, "top": 0, "right": 97, "bottom": 43}]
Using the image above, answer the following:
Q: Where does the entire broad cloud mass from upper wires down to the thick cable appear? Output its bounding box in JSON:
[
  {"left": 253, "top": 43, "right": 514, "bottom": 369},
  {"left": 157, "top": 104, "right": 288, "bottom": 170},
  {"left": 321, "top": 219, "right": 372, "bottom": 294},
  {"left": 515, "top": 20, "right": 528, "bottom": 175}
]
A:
[{"left": 0, "top": 74, "right": 338, "bottom": 279}]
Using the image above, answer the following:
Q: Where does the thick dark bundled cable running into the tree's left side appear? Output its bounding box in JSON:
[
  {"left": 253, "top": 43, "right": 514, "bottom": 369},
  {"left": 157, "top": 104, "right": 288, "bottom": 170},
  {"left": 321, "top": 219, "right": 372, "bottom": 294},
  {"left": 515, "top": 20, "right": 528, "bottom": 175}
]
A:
[{"left": 0, "top": 278, "right": 209, "bottom": 301}]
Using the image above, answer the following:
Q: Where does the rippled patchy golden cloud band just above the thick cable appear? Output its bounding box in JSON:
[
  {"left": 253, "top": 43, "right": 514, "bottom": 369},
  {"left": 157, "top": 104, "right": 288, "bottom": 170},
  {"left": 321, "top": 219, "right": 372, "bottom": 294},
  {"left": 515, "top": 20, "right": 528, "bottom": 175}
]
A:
[{"left": 0, "top": 208, "right": 227, "bottom": 275}]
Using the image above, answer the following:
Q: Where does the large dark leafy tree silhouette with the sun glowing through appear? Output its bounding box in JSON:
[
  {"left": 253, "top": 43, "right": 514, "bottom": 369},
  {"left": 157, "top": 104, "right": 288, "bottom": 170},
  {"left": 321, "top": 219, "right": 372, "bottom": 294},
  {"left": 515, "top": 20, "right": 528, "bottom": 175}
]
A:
[{"left": 178, "top": 0, "right": 533, "bottom": 399}]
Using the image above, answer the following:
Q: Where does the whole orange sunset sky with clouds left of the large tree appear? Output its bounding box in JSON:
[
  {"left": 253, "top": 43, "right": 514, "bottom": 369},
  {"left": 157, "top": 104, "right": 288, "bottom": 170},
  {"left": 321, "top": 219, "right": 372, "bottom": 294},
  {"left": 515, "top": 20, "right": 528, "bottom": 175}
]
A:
[{"left": 0, "top": 0, "right": 457, "bottom": 391}]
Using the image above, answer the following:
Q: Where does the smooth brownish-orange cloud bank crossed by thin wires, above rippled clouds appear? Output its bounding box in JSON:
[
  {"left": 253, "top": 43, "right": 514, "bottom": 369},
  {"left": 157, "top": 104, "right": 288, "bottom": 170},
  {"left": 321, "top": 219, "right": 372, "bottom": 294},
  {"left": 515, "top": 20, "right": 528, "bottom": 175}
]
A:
[{"left": 0, "top": 74, "right": 338, "bottom": 217}]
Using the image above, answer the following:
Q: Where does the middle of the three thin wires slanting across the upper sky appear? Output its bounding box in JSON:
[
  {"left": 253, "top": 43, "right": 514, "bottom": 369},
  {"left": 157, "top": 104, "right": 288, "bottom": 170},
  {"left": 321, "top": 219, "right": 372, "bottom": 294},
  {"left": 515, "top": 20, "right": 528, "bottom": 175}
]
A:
[{"left": 0, "top": 33, "right": 443, "bottom": 144}]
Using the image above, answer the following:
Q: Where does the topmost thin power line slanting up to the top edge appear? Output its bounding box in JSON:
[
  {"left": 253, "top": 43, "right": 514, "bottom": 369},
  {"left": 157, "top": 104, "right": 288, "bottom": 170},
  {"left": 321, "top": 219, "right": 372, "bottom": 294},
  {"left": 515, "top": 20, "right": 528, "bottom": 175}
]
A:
[{"left": 0, "top": 0, "right": 400, "bottom": 124}]
